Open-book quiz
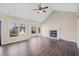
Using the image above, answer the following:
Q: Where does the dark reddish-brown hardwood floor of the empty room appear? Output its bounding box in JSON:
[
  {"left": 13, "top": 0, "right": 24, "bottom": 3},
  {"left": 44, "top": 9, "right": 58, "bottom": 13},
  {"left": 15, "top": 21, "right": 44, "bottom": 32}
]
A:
[{"left": 0, "top": 37, "right": 78, "bottom": 56}]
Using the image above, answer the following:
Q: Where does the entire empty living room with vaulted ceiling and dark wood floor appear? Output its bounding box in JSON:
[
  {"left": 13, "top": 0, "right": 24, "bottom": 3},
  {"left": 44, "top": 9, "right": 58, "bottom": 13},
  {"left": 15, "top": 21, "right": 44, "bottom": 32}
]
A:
[{"left": 0, "top": 3, "right": 79, "bottom": 56}]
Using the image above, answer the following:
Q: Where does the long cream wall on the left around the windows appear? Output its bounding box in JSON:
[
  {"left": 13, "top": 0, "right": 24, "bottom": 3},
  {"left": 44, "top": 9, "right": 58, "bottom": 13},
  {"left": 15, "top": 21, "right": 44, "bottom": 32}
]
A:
[{"left": 0, "top": 14, "right": 39, "bottom": 44}]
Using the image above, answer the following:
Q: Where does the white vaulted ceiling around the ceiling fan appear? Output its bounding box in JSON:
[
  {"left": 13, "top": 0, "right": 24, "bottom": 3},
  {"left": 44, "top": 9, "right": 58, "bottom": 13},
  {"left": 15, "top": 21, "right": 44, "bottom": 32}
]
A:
[{"left": 0, "top": 3, "right": 79, "bottom": 22}]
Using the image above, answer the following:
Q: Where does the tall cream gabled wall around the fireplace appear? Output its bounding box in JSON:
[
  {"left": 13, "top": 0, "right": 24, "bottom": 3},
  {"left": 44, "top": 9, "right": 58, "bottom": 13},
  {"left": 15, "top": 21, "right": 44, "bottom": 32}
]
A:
[{"left": 41, "top": 11, "right": 76, "bottom": 42}]
